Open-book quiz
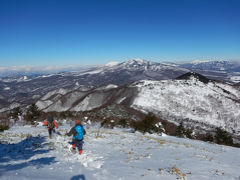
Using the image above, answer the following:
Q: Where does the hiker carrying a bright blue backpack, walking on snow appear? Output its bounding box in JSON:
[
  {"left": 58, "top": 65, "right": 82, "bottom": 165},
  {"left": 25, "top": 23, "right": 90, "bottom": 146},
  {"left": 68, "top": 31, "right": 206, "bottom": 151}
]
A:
[{"left": 65, "top": 120, "right": 86, "bottom": 154}]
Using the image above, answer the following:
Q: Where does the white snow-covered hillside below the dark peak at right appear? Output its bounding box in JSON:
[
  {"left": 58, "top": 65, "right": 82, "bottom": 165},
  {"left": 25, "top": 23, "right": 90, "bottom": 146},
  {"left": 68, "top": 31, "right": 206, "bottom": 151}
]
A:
[{"left": 131, "top": 77, "right": 240, "bottom": 135}]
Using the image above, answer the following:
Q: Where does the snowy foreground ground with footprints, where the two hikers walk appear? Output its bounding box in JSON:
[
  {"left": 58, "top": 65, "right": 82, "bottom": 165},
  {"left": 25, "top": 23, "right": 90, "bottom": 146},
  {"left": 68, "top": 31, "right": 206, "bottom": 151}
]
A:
[{"left": 0, "top": 123, "right": 240, "bottom": 180}]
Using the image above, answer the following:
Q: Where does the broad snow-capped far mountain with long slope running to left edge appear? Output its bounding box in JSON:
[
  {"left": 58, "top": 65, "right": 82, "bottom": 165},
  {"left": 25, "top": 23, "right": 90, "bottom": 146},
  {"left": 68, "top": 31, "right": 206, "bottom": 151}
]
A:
[{"left": 0, "top": 60, "right": 188, "bottom": 112}]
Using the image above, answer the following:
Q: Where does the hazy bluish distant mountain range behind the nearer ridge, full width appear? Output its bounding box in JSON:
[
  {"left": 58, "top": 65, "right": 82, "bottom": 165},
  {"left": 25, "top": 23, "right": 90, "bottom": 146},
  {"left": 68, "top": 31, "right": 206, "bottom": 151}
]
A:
[{"left": 0, "top": 59, "right": 240, "bottom": 112}]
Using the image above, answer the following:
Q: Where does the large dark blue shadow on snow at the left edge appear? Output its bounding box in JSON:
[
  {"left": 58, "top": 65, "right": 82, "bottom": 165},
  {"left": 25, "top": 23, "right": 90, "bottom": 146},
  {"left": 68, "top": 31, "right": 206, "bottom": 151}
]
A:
[{"left": 0, "top": 137, "right": 56, "bottom": 176}]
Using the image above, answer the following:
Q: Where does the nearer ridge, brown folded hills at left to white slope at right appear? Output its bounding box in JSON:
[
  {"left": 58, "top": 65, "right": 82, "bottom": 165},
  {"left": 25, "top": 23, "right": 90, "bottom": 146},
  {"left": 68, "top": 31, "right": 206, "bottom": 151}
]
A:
[{"left": 37, "top": 73, "right": 240, "bottom": 140}]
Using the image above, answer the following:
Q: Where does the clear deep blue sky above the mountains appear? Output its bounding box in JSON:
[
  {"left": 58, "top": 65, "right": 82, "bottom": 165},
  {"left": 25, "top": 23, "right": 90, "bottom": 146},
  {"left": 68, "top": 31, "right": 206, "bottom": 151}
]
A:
[{"left": 0, "top": 0, "right": 240, "bottom": 66}]
